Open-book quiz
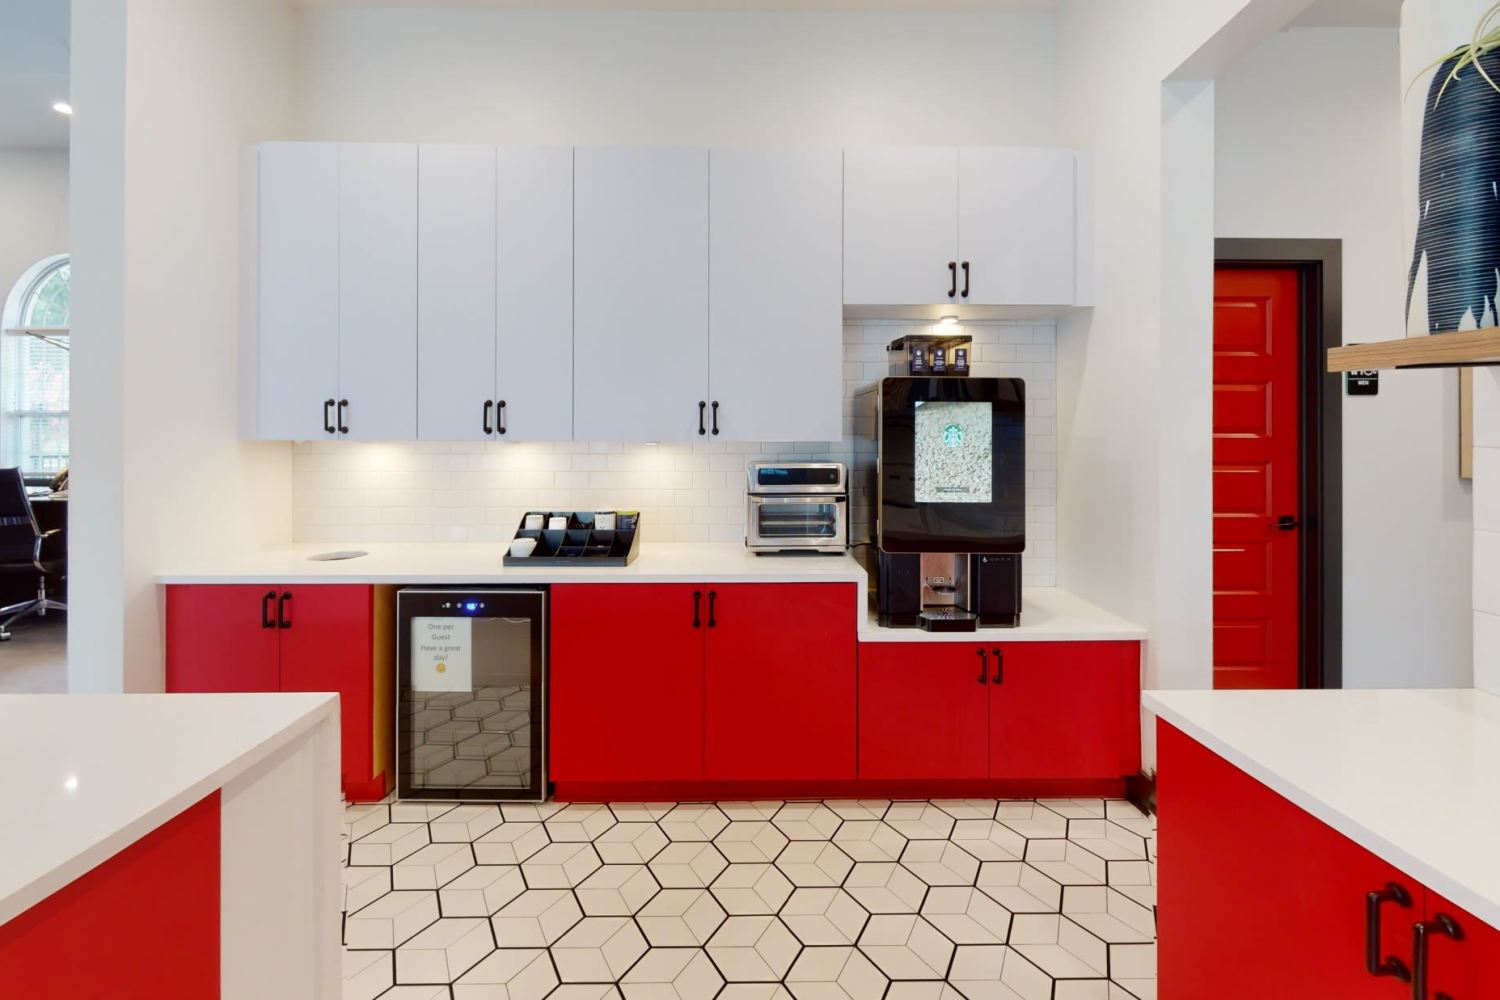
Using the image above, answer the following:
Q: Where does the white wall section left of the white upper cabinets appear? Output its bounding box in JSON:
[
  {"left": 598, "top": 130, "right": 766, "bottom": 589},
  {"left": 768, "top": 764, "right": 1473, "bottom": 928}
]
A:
[{"left": 69, "top": 0, "right": 296, "bottom": 691}]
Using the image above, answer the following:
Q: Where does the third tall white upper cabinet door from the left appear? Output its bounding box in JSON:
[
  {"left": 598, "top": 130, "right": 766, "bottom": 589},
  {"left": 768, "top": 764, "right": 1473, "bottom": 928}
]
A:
[{"left": 417, "top": 145, "right": 495, "bottom": 441}]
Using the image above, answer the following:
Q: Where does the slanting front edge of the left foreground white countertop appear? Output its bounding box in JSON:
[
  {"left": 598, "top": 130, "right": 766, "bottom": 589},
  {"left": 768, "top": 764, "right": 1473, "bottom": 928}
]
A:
[{"left": 0, "top": 694, "right": 339, "bottom": 925}]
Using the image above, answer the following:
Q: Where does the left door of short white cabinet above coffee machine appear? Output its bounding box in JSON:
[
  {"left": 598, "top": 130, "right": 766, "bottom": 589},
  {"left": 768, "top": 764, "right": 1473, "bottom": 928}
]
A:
[{"left": 843, "top": 147, "right": 959, "bottom": 306}]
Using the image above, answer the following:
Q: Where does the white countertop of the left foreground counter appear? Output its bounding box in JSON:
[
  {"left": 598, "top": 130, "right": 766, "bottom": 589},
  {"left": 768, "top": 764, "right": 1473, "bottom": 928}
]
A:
[{"left": 0, "top": 694, "right": 338, "bottom": 924}]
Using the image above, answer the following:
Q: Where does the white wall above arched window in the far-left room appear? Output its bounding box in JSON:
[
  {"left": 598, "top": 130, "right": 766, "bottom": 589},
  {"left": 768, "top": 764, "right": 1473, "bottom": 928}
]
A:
[{"left": 0, "top": 148, "right": 68, "bottom": 300}]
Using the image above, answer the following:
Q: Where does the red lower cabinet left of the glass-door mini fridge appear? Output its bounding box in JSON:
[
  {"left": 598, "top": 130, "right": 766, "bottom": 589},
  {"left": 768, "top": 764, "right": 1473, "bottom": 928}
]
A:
[{"left": 167, "top": 583, "right": 395, "bottom": 801}]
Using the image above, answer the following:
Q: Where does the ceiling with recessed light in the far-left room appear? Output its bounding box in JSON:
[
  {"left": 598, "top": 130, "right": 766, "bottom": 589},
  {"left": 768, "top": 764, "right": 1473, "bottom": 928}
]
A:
[{"left": 0, "top": 0, "right": 69, "bottom": 147}]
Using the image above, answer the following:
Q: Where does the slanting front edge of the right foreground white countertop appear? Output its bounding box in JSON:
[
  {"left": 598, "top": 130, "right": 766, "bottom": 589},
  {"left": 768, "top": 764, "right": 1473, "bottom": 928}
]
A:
[{"left": 1142, "top": 691, "right": 1500, "bottom": 928}]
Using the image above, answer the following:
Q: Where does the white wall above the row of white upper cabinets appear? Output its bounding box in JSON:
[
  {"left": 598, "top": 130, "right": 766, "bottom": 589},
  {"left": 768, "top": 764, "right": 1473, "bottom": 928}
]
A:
[{"left": 303, "top": 9, "right": 1056, "bottom": 145}]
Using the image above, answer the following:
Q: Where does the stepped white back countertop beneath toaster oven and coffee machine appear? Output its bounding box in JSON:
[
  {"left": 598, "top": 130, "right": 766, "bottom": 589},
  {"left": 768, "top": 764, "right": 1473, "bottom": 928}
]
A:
[{"left": 156, "top": 541, "right": 1146, "bottom": 642}]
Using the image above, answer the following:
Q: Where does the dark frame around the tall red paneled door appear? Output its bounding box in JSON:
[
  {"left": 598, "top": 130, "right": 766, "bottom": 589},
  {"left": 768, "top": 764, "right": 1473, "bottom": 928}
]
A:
[{"left": 1214, "top": 238, "right": 1344, "bottom": 688}]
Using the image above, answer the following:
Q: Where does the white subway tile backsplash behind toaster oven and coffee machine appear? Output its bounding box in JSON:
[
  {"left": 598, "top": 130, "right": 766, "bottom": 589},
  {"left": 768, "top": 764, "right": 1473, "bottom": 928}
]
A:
[{"left": 293, "top": 321, "right": 1058, "bottom": 586}]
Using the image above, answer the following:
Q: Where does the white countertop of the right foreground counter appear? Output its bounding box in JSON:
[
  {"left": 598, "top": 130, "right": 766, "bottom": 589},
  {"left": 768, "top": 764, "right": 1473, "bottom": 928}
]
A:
[{"left": 1143, "top": 688, "right": 1500, "bottom": 927}]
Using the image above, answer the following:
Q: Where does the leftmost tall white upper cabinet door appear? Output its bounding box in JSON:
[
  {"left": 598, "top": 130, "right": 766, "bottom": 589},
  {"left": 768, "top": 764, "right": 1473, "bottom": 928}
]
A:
[{"left": 255, "top": 142, "right": 339, "bottom": 441}]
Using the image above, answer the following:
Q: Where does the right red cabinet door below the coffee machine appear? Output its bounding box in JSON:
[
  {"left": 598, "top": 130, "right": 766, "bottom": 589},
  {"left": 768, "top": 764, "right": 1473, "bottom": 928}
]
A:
[{"left": 990, "top": 642, "right": 1140, "bottom": 778}]
